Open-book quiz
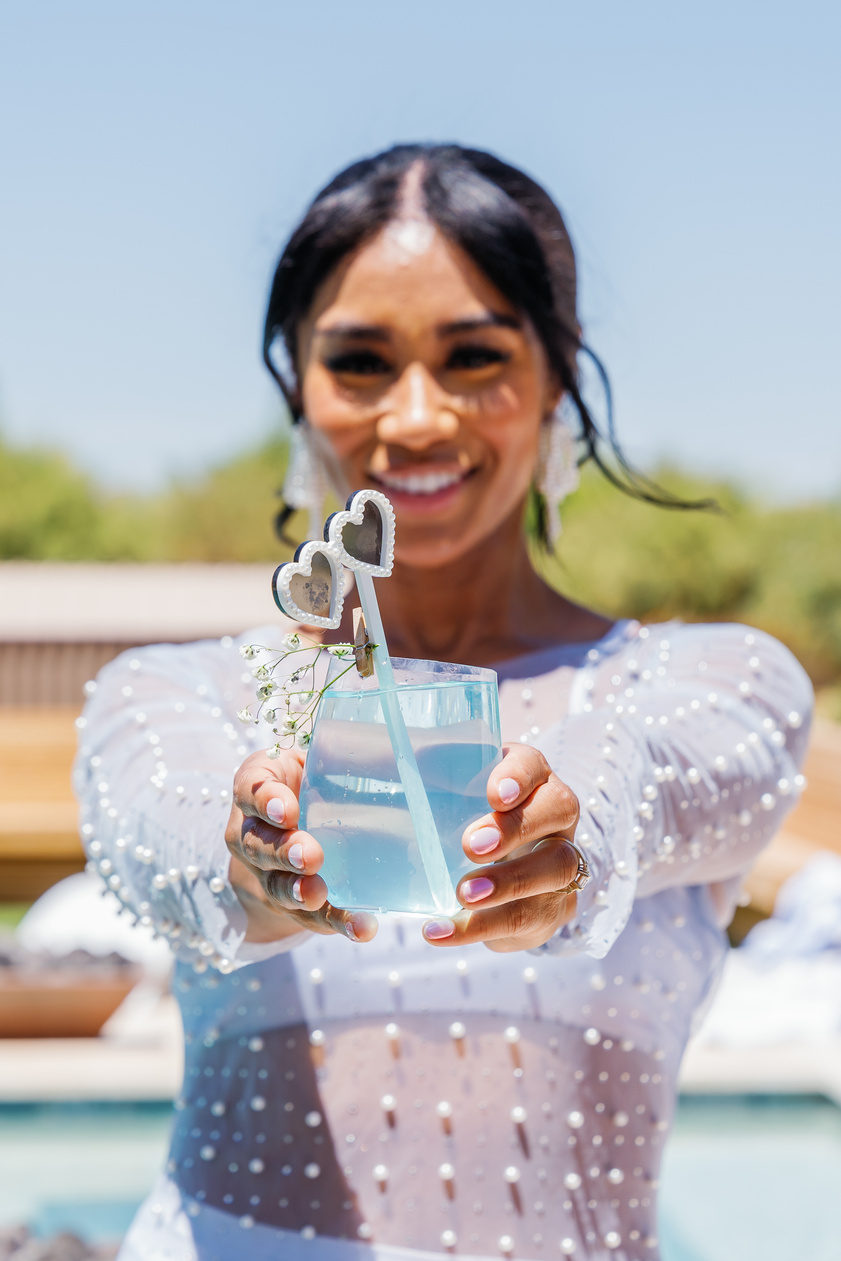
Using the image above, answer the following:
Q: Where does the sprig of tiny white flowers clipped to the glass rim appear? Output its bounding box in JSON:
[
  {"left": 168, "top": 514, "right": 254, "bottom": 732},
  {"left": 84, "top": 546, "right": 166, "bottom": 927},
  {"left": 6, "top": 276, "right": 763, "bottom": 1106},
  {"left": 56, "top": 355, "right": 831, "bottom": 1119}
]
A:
[{"left": 237, "top": 632, "right": 368, "bottom": 758}]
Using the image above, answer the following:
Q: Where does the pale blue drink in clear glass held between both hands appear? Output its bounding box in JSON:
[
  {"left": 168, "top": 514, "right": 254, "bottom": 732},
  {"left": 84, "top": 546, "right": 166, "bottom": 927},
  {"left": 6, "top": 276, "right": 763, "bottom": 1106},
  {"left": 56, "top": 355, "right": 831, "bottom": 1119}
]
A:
[{"left": 300, "top": 657, "right": 501, "bottom": 915}]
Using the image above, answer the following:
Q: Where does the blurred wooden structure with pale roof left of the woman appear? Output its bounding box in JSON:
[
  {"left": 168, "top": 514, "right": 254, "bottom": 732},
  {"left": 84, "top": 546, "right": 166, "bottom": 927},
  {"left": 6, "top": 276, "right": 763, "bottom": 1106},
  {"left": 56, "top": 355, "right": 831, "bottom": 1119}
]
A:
[{"left": 0, "top": 561, "right": 287, "bottom": 902}]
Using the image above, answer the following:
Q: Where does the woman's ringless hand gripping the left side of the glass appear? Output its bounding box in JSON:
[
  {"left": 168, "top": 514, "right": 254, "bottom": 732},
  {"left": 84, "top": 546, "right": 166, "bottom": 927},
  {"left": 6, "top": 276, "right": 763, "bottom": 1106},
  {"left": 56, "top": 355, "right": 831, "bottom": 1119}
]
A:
[{"left": 224, "top": 749, "right": 377, "bottom": 942}]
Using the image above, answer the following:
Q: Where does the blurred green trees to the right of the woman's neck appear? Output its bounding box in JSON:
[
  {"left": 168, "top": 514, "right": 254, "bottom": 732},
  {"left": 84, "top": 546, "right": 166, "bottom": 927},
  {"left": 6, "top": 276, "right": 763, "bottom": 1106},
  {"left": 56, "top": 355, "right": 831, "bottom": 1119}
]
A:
[{"left": 533, "top": 469, "right": 841, "bottom": 685}]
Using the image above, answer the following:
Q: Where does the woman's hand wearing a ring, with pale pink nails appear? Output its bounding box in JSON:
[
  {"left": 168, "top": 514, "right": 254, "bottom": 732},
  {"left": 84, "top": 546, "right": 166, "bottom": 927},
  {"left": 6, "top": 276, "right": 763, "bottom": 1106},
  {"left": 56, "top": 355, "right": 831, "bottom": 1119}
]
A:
[{"left": 424, "top": 744, "right": 579, "bottom": 951}]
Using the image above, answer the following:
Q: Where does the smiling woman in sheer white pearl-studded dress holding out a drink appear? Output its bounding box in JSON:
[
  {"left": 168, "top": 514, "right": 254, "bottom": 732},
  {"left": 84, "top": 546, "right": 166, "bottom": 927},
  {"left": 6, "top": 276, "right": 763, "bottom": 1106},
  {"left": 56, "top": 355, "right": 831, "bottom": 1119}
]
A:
[{"left": 78, "top": 146, "right": 809, "bottom": 1258}]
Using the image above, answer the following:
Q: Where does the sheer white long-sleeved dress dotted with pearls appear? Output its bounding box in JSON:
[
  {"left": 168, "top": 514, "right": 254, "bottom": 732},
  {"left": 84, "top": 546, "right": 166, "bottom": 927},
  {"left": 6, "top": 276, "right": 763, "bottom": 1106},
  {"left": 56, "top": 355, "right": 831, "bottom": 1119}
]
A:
[{"left": 76, "top": 622, "right": 811, "bottom": 1261}]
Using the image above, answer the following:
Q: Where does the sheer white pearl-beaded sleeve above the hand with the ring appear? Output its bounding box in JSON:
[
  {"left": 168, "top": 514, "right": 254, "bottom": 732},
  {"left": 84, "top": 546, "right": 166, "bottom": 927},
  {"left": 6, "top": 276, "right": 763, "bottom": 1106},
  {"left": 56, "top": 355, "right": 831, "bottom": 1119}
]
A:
[{"left": 537, "top": 624, "right": 812, "bottom": 957}]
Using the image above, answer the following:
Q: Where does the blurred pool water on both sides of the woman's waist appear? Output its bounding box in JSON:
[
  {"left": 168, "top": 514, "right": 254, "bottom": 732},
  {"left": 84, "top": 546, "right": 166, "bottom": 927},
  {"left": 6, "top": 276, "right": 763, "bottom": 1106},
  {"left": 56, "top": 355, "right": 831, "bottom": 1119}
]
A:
[{"left": 0, "top": 1096, "right": 841, "bottom": 1261}]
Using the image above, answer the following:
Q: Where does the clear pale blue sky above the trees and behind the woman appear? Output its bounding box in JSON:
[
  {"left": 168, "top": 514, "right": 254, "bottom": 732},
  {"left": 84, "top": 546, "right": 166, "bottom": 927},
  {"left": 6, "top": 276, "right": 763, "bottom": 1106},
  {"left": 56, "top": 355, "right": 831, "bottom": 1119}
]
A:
[{"left": 0, "top": 0, "right": 841, "bottom": 498}]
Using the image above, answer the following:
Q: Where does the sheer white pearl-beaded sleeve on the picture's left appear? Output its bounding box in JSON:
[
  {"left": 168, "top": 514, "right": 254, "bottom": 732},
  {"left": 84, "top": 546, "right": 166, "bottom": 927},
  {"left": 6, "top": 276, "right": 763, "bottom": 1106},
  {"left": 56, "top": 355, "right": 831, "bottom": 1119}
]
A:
[{"left": 74, "top": 629, "right": 299, "bottom": 971}]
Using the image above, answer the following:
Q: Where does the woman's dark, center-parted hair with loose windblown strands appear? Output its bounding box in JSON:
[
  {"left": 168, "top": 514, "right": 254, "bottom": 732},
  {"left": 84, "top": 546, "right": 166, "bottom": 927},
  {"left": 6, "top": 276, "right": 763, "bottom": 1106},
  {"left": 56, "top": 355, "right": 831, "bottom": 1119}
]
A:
[{"left": 262, "top": 144, "right": 710, "bottom": 542}]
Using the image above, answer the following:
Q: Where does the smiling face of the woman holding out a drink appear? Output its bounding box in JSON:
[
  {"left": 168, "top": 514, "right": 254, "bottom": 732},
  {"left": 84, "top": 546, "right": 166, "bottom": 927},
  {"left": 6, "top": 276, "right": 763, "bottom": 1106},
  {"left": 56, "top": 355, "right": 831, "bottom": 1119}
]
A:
[{"left": 299, "top": 219, "right": 559, "bottom": 567}]
